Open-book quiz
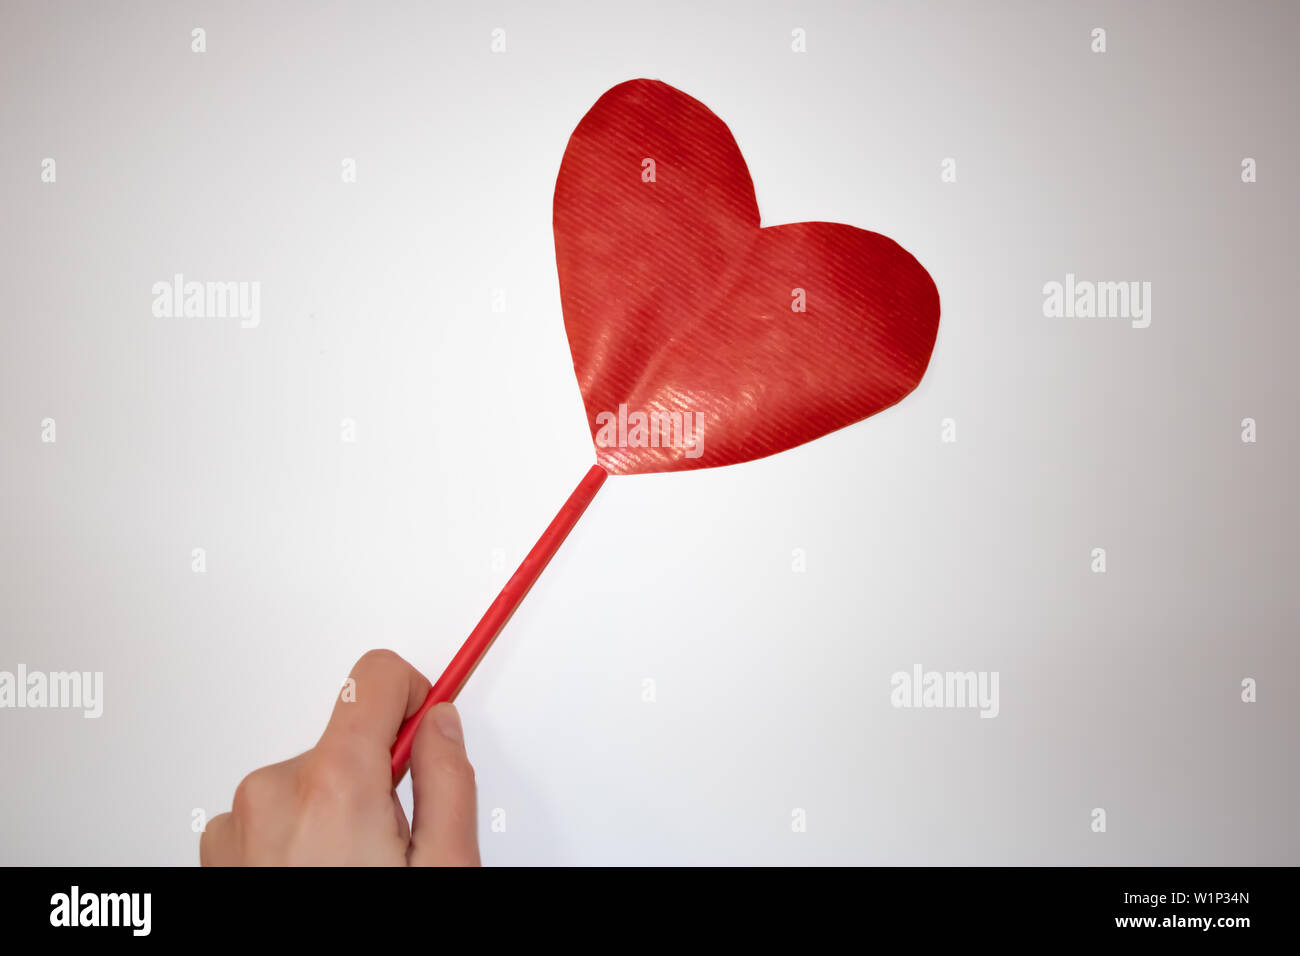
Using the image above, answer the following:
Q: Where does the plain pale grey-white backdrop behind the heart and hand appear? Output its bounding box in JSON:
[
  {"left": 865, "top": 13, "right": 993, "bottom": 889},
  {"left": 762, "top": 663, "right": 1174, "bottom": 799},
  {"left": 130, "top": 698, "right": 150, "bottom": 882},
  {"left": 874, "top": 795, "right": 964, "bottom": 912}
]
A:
[{"left": 0, "top": 0, "right": 1300, "bottom": 864}]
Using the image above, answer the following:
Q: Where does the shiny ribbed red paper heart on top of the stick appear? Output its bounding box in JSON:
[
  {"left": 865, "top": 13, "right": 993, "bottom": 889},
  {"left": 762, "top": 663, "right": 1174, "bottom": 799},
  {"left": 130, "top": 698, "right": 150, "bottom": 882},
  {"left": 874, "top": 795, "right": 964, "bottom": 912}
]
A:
[{"left": 555, "top": 79, "right": 939, "bottom": 475}]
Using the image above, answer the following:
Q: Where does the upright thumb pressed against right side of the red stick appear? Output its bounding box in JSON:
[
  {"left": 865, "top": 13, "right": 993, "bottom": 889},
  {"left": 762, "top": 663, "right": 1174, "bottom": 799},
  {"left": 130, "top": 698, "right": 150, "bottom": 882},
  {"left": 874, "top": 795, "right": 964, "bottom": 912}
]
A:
[{"left": 408, "top": 704, "right": 478, "bottom": 866}]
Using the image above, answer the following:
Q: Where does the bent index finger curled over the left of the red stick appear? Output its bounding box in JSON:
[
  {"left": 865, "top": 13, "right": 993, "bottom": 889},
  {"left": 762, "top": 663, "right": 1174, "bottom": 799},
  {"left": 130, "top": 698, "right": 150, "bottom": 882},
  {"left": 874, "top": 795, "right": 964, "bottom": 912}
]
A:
[{"left": 317, "top": 650, "right": 429, "bottom": 750}]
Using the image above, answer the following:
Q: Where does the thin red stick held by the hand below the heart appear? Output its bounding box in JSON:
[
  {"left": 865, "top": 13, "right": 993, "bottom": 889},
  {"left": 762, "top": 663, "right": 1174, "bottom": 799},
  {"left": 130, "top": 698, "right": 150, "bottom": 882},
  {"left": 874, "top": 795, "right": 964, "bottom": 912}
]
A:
[{"left": 391, "top": 464, "right": 607, "bottom": 783}]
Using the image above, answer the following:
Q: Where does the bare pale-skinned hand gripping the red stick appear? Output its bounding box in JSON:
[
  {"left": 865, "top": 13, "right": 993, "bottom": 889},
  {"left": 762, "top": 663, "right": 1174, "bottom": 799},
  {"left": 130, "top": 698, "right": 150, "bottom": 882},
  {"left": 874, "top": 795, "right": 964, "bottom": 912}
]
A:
[{"left": 199, "top": 650, "right": 480, "bottom": 866}]
